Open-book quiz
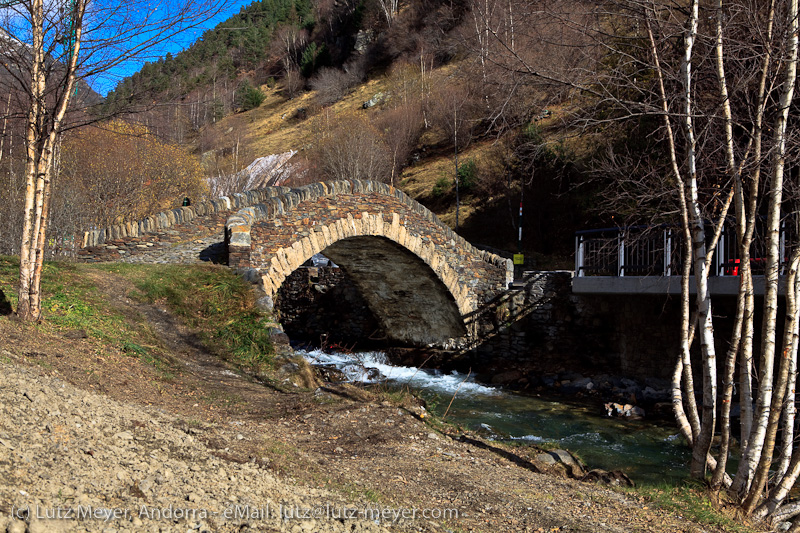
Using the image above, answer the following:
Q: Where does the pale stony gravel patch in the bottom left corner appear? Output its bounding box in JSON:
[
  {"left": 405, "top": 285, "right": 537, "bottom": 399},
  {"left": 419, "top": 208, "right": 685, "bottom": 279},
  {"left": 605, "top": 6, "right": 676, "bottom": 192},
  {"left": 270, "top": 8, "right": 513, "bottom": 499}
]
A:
[{"left": 0, "top": 364, "right": 396, "bottom": 532}]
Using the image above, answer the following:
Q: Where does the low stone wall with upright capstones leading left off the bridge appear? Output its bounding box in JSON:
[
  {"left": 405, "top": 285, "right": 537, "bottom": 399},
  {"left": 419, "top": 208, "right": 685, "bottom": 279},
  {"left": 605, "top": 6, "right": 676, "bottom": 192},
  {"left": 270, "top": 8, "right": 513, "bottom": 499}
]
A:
[{"left": 77, "top": 187, "right": 291, "bottom": 262}]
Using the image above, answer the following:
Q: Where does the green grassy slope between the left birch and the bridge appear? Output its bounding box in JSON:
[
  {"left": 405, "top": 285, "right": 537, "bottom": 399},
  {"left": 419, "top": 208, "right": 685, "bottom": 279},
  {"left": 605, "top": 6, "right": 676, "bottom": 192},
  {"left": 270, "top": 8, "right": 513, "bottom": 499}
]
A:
[{"left": 0, "top": 256, "right": 273, "bottom": 379}]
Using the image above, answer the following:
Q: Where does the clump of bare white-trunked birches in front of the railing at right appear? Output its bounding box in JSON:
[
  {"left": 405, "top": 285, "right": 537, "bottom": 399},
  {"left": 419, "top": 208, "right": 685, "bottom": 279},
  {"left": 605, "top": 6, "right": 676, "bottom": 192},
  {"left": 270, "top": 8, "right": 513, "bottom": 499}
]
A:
[{"left": 476, "top": 0, "right": 800, "bottom": 527}]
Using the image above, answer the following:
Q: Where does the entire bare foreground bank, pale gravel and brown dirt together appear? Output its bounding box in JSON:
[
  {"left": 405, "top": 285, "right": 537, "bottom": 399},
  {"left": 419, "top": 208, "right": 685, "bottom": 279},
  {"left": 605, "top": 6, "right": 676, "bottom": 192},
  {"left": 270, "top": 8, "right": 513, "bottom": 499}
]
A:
[{"left": 0, "top": 273, "right": 736, "bottom": 532}]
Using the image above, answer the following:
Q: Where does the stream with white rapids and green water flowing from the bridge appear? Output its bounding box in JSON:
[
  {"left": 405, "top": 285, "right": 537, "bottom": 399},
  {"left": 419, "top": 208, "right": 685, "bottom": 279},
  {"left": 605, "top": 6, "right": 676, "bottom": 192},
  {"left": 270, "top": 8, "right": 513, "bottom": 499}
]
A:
[{"left": 300, "top": 350, "right": 690, "bottom": 484}]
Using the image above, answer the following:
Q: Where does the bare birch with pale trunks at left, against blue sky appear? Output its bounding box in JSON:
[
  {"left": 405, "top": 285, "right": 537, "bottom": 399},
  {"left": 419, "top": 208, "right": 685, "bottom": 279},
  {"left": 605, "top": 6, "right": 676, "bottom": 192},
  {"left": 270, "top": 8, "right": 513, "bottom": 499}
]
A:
[{"left": 0, "top": 0, "right": 233, "bottom": 320}]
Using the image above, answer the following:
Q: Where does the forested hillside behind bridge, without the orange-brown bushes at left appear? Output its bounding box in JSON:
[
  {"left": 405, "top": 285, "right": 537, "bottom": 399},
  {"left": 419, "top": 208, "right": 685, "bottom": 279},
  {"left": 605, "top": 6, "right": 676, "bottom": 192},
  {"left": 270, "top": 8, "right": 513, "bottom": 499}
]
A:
[{"left": 97, "top": 0, "right": 595, "bottom": 264}]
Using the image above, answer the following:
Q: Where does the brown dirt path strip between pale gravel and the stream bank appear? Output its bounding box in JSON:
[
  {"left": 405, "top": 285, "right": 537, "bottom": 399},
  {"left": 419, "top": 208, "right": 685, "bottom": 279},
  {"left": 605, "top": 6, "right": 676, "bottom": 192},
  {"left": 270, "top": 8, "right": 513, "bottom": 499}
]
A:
[{"left": 0, "top": 273, "right": 740, "bottom": 532}]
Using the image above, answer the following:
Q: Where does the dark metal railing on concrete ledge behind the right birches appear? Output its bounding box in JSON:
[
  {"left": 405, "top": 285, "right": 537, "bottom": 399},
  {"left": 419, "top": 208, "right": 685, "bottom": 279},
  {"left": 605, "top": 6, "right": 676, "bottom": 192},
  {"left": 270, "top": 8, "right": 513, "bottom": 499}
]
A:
[{"left": 575, "top": 223, "right": 796, "bottom": 277}]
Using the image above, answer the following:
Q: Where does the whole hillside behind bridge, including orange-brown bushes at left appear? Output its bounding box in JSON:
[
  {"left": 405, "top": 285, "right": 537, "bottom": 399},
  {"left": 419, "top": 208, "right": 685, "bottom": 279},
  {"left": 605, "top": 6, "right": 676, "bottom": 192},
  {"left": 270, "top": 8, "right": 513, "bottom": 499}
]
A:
[{"left": 0, "top": 0, "right": 612, "bottom": 267}]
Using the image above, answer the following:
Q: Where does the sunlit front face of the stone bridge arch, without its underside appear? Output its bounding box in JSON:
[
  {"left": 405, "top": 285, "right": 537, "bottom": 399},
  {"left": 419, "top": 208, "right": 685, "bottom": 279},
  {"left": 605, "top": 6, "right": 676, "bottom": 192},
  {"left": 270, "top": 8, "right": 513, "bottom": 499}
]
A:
[{"left": 226, "top": 181, "right": 512, "bottom": 344}]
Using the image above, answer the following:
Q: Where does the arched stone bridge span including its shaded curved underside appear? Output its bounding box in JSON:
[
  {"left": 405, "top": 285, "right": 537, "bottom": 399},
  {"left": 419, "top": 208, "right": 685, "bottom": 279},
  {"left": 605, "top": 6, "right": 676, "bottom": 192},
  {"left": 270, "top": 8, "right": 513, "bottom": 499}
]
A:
[{"left": 225, "top": 180, "right": 513, "bottom": 345}]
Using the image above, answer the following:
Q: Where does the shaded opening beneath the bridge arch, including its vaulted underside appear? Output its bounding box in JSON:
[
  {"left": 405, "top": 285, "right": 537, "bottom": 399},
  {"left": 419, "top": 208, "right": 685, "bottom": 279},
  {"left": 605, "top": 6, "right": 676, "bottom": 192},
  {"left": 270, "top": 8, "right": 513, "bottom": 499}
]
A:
[{"left": 276, "top": 235, "right": 467, "bottom": 346}]
